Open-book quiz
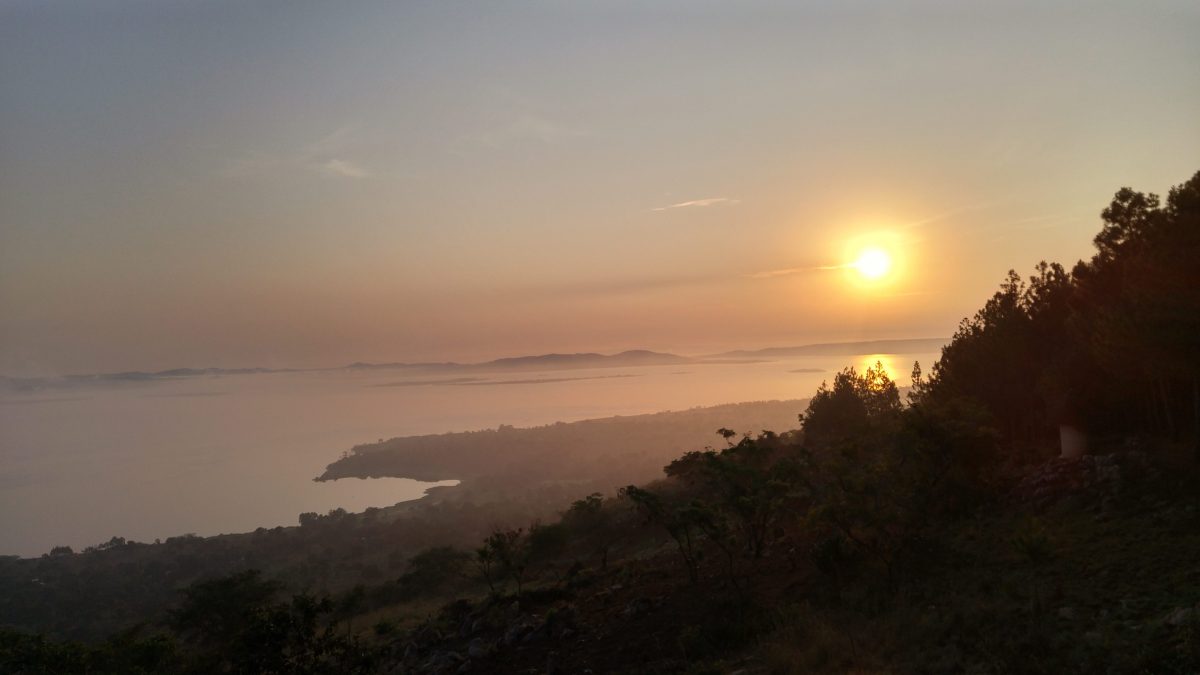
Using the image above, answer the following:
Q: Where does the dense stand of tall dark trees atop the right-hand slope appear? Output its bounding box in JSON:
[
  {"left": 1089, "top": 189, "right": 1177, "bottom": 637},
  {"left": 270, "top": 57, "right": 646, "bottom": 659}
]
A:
[{"left": 923, "top": 168, "right": 1200, "bottom": 456}]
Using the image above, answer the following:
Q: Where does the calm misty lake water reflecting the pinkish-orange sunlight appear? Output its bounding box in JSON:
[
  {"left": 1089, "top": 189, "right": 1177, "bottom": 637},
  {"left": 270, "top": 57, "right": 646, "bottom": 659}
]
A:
[{"left": 0, "top": 353, "right": 937, "bottom": 556}]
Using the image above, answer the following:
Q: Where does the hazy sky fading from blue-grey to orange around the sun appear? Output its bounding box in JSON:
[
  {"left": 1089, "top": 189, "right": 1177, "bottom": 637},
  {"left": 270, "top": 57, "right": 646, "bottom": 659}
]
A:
[{"left": 0, "top": 0, "right": 1200, "bottom": 375}]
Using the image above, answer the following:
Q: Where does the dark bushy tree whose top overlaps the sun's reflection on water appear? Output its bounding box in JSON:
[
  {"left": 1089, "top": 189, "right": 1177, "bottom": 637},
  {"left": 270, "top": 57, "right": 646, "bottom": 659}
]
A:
[{"left": 800, "top": 357, "right": 996, "bottom": 581}]
